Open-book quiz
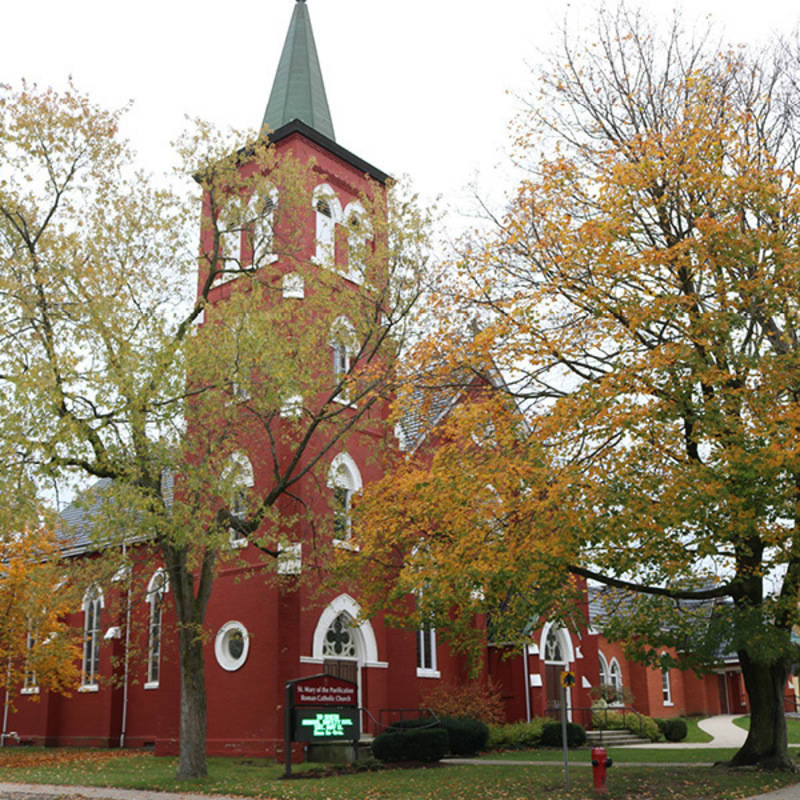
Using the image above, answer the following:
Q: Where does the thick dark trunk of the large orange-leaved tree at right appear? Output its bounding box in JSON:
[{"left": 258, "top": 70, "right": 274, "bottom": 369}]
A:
[{"left": 730, "top": 651, "right": 796, "bottom": 771}]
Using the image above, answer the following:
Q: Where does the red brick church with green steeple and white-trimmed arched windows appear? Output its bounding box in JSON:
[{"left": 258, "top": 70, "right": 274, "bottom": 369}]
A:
[{"left": 3, "top": 0, "right": 745, "bottom": 756}]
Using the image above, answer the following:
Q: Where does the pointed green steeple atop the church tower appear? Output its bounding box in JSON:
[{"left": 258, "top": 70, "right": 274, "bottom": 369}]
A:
[{"left": 261, "top": 0, "right": 336, "bottom": 139}]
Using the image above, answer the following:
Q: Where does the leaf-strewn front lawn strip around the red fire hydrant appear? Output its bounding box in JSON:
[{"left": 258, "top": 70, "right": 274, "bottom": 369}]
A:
[{"left": 0, "top": 749, "right": 796, "bottom": 800}]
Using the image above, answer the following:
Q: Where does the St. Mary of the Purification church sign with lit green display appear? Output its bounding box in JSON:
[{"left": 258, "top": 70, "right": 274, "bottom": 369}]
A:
[{"left": 283, "top": 674, "right": 361, "bottom": 778}]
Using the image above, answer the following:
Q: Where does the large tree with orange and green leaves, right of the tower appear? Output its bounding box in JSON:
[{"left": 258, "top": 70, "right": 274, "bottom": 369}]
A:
[{"left": 352, "top": 7, "right": 800, "bottom": 768}]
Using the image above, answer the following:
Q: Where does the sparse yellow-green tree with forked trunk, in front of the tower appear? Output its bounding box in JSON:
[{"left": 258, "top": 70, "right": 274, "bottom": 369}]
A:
[{"left": 0, "top": 87, "right": 432, "bottom": 777}]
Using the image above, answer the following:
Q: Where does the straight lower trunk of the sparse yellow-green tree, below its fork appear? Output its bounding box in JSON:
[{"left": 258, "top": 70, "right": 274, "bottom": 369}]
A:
[{"left": 178, "top": 626, "right": 208, "bottom": 778}]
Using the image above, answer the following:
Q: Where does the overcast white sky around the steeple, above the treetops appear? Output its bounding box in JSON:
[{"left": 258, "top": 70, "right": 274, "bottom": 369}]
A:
[{"left": 0, "top": 0, "right": 798, "bottom": 223}]
